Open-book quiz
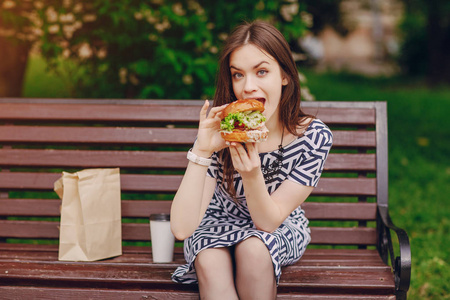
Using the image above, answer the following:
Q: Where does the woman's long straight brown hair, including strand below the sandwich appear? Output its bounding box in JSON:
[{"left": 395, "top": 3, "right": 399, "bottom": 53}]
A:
[{"left": 214, "top": 21, "right": 310, "bottom": 197}]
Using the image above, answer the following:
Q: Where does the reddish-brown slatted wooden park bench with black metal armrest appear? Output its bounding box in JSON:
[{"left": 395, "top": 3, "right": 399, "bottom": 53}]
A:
[{"left": 0, "top": 98, "right": 411, "bottom": 299}]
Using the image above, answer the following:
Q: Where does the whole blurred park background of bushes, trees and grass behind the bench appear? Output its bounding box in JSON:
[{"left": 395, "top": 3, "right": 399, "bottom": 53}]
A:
[{"left": 0, "top": 0, "right": 450, "bottom": 299}]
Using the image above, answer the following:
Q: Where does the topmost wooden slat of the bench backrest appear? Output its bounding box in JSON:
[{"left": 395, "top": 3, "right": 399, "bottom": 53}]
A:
[{"left": 0, "top": 101, "right": 375, "bottom": 125}]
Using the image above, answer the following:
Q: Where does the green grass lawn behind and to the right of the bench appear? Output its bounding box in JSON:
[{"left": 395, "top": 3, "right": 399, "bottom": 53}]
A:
[{"left": 24, "top": 56, "right": 450, "bottom": 299}]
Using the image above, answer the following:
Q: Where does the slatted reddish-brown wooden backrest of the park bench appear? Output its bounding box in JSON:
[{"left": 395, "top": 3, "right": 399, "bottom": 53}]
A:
[{"left": 0, "top": 98, "right": 387, "bottom": 245}]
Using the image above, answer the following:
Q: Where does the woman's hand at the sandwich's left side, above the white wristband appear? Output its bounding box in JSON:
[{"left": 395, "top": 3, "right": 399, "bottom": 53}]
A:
[{"left": 192, "top": 100, "right": 227, "bottom": 157}]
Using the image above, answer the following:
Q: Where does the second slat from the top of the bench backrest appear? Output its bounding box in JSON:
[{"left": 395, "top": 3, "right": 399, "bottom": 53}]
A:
[{"left": 0, "top": 125, "right": 376, "bottom": 148}]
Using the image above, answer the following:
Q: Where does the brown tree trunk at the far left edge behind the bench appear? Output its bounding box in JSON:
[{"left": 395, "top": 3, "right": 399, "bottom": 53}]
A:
[{"left": 0, "top": 36, "right": 31, "bottom": 97}]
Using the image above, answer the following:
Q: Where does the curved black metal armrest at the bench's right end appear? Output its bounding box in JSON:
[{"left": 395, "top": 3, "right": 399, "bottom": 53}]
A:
[{"left": 377, "top": 204, "right": 411, "bottom": 299}]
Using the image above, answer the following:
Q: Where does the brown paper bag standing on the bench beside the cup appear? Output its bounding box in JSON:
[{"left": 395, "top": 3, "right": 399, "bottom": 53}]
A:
[{"left": 54, "top": 168, "right": 122, "bottom": 261}]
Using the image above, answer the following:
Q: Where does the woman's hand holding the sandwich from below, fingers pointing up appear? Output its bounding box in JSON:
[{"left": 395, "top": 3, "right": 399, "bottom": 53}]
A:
[{"left": 230, "top": 142, "right": 261, "bottom": 176}]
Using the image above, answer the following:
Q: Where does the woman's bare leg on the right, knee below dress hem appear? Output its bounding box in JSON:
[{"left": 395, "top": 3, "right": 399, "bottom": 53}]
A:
[{"left": 234, "top": 237, "right": 277, "bottom": 300}]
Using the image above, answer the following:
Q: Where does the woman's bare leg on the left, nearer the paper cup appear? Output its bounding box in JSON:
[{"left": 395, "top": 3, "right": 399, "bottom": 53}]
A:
[{"left": 195, "top": 248, "right": 238, "bottom": 300}]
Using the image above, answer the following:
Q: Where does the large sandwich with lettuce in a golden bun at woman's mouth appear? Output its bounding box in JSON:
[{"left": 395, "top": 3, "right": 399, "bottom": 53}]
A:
[{"left": 220, "top": 99, "right": 269, "bottom": 143}]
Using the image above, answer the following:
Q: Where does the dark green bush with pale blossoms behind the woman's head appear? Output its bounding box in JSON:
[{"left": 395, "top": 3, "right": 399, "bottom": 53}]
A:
[{"left": 16, "top": 0, "right": 305, "bottom": 99}]
